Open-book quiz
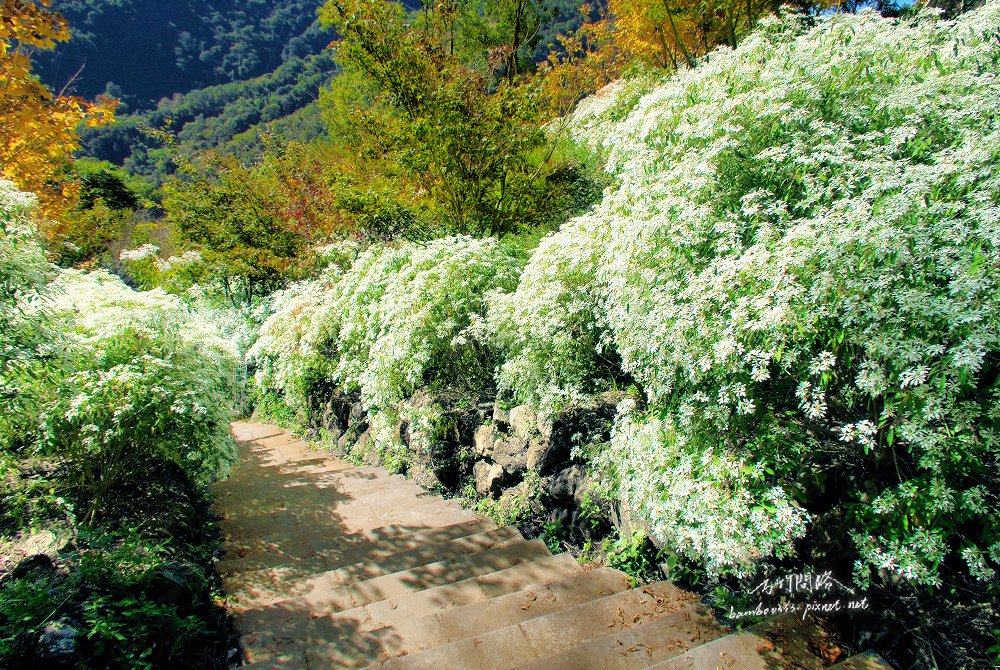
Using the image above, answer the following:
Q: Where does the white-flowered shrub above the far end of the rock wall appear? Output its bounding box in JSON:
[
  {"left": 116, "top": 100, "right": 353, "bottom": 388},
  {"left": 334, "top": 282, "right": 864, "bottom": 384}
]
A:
[{"left": 250, "top": 237, "right": 520, "bottom": 414}]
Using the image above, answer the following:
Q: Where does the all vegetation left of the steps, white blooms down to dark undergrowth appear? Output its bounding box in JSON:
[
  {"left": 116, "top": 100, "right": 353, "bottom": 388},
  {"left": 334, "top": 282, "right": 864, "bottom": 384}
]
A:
[{"left": 0, "top": 182, "right": 240, "bottom": 669}]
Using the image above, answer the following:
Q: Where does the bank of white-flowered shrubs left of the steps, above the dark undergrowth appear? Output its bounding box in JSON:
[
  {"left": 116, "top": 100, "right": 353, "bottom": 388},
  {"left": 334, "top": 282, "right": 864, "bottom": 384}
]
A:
[{"left": 0, "top": 183, "right": 241, "bottom": 513}]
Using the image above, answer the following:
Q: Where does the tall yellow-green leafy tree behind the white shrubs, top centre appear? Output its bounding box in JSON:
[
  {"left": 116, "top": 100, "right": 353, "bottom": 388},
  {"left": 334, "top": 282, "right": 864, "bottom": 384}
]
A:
[{"left": 321, "top": 0, "right": 586, "bottom": 239}]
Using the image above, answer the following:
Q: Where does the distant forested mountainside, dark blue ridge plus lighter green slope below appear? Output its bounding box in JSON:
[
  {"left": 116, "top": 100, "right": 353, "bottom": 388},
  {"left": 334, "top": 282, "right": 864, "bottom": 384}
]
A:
[{"left": 62, "top": 0, "right": 596, "bottom": 182}]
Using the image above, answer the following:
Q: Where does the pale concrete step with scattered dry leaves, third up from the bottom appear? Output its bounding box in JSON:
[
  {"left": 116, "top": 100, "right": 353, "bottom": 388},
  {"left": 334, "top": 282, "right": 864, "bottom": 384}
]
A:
[{"left": 371, "top": 582, "right": 708, "bottom": 670}]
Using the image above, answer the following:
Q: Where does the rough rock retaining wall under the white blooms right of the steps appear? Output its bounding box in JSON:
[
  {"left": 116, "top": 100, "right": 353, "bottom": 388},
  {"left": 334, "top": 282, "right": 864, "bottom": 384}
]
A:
[{"left": 300, "top": 389, "right": 619, "bottom": 552}]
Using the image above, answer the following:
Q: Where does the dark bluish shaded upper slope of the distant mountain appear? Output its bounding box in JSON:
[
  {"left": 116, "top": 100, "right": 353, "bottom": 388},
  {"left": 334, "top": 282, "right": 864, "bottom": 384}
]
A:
[{"left": 36, "top": 0, "right": 332, "bottom": 110}]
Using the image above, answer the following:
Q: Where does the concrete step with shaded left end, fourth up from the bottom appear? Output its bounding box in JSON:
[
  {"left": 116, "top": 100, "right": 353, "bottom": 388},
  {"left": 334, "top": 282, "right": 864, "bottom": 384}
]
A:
[{"left": 306, "top": 569, "right": 629, "bottom": 667}]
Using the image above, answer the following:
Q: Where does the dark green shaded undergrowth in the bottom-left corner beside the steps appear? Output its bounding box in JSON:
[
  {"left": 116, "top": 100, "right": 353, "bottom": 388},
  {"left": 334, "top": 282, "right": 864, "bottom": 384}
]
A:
[{"left": 0, "top": 490, "right": 225, "bottom": 670}]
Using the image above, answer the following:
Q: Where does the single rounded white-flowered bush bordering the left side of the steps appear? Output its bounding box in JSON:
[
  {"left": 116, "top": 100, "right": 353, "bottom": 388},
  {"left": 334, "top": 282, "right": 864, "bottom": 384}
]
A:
[{"left": 31, "top": 270, "right": 241, "bottom": 513}]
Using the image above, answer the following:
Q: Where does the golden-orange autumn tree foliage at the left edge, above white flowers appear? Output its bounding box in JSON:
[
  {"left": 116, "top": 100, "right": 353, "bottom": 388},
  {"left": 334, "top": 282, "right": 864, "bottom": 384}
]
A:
[{"left": 0, "top": 0, "right": 117, "bottom": 217}]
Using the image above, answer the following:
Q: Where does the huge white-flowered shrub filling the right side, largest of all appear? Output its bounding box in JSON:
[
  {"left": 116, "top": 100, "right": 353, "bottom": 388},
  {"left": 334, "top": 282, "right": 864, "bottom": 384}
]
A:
[{"left": 489, "top": 2, "right": 1000, "bottom": 585}]
